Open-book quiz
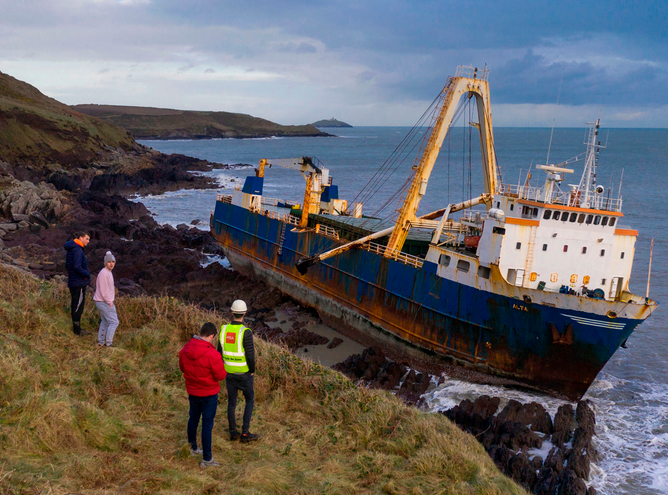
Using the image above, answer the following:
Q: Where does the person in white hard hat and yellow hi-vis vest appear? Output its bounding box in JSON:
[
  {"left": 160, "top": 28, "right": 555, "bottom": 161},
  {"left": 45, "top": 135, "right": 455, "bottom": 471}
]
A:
[{"left": 216, "top": 299, "right": 258, "bottom": 443}]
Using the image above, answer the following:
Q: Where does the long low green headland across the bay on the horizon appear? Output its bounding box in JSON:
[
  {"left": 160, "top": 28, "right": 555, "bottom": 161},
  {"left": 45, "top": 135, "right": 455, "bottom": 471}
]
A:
[{"left": 72, "top": 105, "right": 329, "bottom": 139}]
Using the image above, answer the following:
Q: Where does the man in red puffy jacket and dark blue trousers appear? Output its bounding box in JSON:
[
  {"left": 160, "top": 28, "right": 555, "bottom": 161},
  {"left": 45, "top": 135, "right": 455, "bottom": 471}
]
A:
[{"left": 179, "top": 323, "right": 227, "bottom": 467}]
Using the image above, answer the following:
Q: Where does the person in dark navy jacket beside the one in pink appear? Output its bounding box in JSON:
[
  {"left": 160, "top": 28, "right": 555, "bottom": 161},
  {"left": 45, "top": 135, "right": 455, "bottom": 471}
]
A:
[{"left": 64, "top": 232, "right": 90, "bottom": 336}]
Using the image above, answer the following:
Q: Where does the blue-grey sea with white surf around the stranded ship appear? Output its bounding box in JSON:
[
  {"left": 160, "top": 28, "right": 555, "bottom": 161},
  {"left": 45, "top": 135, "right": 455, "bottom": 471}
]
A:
[{"left": 138, "top": 125, "right": 668, "bottom": 495}]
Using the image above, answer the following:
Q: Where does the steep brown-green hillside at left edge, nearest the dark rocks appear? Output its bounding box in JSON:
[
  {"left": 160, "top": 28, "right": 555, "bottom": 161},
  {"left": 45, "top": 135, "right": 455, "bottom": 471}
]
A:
[{"left": 0, "top": 72, "right": 138, "bottom": 166}]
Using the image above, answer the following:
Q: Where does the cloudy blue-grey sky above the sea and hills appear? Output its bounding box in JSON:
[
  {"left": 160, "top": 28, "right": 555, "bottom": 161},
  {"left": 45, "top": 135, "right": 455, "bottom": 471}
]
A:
[{"left": 0, "top": 0, "right": 668, "bottom": 128}]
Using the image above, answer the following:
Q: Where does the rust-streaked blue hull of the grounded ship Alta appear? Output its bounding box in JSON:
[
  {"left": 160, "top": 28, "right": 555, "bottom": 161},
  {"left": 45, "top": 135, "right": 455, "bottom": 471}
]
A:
[{"left": 211, "top": 201, "right": 642, "bottom": 400}]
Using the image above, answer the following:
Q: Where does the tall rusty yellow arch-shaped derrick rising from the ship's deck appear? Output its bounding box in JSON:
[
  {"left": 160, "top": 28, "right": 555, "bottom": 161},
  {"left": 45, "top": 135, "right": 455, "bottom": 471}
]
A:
[{"left": 385, "top": 66, "right": 498, "bottom": 257}]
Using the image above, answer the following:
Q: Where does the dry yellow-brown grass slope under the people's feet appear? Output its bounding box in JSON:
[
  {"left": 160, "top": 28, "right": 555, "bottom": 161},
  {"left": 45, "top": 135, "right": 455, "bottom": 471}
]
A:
[{"left": 0, "top": 265, "right": 525, "bottom": 495}]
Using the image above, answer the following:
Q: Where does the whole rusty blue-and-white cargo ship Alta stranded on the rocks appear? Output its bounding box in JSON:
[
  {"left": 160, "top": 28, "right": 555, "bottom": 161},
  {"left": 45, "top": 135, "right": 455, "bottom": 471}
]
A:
[{"left": 210, "top": 66, "right": 658, "bottom": 401}]
